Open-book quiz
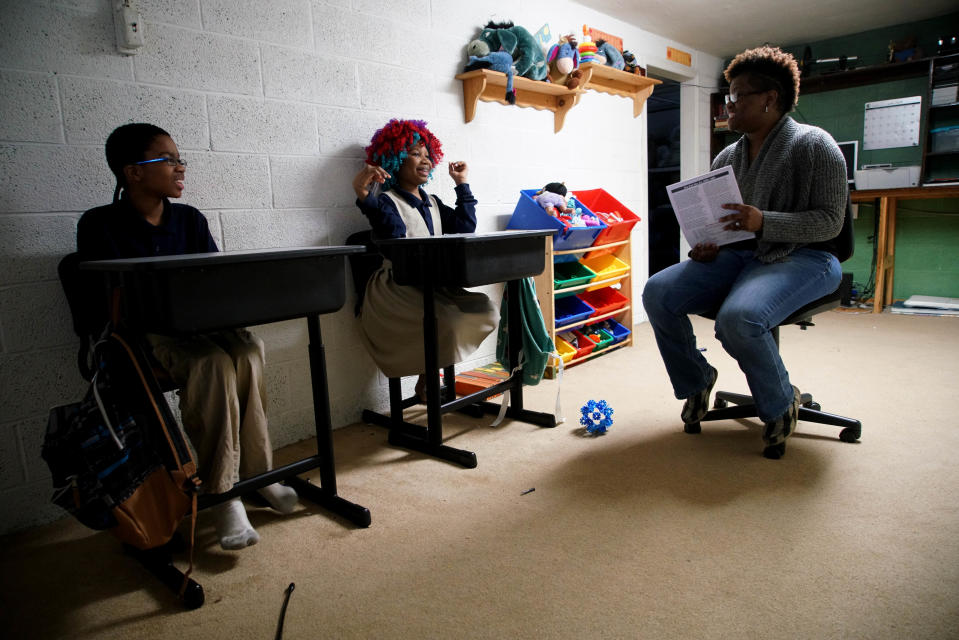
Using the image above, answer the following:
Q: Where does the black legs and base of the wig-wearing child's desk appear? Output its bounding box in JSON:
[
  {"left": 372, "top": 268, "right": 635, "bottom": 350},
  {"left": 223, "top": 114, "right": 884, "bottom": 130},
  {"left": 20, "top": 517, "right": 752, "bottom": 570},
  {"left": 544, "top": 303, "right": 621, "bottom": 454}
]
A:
[{"left": 363, "top": 231, "right": 556, "bottom": 469}]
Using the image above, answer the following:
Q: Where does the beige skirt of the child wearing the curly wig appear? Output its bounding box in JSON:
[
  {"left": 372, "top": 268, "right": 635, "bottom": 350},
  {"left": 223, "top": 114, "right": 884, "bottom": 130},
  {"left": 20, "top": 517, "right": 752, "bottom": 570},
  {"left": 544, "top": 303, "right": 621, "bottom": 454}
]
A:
[{"left": 360, "top": 261, "right": 499, "bottom": 378}]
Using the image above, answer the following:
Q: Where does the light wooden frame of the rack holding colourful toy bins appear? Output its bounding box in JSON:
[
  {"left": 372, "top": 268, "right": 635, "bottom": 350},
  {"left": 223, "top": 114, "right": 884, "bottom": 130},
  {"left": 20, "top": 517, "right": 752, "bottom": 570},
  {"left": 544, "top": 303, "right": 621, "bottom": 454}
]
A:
[{"left": 534, "top": 232, "right": 633, "bottom": 377}]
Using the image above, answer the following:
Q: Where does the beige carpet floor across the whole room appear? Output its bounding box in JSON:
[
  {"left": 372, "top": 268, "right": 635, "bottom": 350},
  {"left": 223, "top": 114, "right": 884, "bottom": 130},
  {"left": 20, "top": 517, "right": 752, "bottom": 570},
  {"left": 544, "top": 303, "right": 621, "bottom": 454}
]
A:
[{"left": 0, "top": 312, "right": 959, "bottom": 640}]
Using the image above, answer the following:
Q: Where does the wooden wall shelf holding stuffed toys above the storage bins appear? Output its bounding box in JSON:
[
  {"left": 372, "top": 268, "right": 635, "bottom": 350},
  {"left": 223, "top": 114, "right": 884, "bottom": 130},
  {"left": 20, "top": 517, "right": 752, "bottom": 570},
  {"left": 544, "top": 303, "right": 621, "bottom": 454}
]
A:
[{"left": 456, "top": 63, "right": 660, "bottom": 133}]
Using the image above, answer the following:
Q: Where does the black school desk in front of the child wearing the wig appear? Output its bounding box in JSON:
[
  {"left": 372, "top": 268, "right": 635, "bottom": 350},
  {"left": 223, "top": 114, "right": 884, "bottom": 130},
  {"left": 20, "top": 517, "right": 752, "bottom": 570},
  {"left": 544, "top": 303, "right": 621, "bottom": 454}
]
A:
[{"left": 363, "top": 229, "right": 556, "bottom": 468}]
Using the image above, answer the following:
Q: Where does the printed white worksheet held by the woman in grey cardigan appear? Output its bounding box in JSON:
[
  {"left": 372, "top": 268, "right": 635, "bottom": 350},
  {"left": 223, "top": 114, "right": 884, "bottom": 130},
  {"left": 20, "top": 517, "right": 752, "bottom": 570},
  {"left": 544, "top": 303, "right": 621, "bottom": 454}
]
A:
[{"left": 666, "top": 167, "right": 756, "bottom": 247}]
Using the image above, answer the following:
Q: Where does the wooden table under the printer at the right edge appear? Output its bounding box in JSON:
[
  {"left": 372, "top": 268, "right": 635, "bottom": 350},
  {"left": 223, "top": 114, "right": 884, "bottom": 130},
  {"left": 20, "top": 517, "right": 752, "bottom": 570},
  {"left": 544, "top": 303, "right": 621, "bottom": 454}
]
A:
[{"left": 849, "top": 186, "right": 959, "bottom": 313}]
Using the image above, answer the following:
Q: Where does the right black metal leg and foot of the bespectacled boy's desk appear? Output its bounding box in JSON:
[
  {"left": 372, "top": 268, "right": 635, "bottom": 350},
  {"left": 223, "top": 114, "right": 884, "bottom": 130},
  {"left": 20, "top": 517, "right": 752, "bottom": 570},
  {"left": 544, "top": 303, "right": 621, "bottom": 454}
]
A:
[{"left": 287, "top": 314, "right": 370, "bottom": 527}]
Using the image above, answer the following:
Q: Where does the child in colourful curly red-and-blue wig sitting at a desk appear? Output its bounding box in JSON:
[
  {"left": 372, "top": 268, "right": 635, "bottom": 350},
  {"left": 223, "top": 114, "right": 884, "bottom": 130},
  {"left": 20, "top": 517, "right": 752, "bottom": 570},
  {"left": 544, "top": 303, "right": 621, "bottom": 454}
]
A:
[{"left": 353, "top": 120, "right": 497, "bottom": 400}]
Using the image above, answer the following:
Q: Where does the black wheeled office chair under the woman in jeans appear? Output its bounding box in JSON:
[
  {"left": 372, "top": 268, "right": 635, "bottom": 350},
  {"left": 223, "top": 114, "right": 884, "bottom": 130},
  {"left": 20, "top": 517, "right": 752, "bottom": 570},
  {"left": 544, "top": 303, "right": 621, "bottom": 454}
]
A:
[{"left": 685, "top": 202, "right": 862, "bottom": 442}]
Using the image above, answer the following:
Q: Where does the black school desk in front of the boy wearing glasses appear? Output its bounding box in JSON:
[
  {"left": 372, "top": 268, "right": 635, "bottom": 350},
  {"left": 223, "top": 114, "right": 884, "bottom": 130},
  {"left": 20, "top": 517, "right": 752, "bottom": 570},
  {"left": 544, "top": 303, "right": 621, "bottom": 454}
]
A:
[{"left": 80, "top": 247, "right": 370, "bottom": 527}]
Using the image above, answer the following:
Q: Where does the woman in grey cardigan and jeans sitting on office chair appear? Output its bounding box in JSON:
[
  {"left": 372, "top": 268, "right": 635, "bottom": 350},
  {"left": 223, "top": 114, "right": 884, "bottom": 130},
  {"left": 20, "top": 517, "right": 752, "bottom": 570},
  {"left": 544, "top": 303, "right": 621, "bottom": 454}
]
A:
[{"left": 643, "top": 47, "right": 848, "bottom": 459}]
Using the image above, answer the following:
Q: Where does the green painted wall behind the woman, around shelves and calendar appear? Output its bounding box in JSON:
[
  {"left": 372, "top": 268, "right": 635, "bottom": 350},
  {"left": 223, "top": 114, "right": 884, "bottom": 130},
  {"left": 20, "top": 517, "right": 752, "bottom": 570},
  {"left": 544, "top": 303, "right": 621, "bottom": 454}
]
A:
[{"left": 783, "top": 13, "right": 959, "bottom": 298}]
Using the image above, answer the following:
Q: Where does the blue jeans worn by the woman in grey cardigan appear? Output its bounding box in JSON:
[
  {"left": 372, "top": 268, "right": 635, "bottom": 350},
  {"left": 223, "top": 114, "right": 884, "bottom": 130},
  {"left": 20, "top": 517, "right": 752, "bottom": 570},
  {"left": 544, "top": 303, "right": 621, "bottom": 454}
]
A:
[{"left": 643, "top": 248, "right": 842, "bottom": 422}]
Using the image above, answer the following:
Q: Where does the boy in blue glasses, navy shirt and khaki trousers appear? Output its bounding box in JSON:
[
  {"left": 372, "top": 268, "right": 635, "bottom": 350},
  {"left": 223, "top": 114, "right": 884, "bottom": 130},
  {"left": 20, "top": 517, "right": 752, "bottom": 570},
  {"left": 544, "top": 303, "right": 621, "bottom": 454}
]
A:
[{"left": 77, "top": 123, "right": 297, "bottom": 549}]
